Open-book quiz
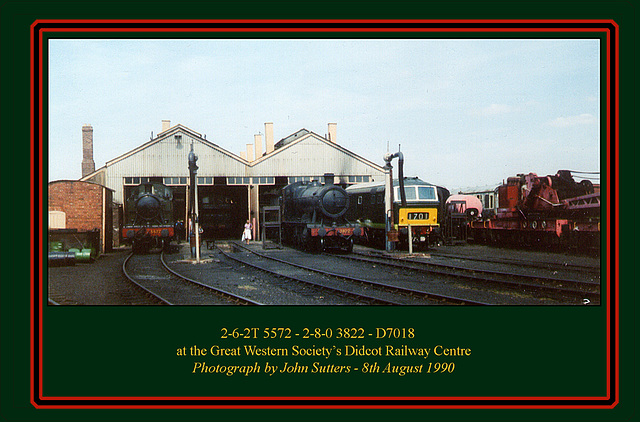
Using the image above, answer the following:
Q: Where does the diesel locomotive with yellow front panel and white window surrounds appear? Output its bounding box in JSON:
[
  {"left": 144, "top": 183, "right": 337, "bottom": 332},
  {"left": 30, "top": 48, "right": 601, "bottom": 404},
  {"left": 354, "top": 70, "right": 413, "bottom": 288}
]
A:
[{"left": 346, "top": 177, "right": 449, "bottom": 249}]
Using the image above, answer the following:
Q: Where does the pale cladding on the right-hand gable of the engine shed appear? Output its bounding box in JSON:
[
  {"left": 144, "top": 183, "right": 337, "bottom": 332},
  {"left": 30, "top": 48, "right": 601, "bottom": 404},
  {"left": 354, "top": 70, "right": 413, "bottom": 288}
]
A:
[{"left": 252, "top": 136, "right": 384, "bottom": 180}]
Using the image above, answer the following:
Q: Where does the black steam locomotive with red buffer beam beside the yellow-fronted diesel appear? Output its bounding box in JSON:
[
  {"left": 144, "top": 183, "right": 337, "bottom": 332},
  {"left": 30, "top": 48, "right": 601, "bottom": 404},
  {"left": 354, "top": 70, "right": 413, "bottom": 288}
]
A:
[{"left": 280, "top": 174, "right": 362, "bottom": 252}]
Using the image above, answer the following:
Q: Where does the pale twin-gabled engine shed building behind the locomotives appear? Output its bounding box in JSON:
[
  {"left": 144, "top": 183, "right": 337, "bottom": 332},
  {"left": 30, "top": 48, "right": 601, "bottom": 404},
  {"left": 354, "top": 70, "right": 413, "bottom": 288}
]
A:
[{"left": 80, "top": 120, "right": 385, "bottom": 238}]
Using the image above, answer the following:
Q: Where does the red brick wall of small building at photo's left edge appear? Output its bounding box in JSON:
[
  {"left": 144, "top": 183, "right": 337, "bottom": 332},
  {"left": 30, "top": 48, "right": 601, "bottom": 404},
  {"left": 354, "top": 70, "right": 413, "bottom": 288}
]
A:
[{"left": 49, "top": 181, "right": 104, "bottom": 237}]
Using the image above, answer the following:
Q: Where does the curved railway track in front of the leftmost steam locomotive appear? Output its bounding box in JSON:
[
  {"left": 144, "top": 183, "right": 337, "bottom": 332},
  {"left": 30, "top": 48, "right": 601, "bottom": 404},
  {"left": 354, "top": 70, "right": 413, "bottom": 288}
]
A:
[{"left": 122, "top": 252, "right": 261, "bottom": 305}]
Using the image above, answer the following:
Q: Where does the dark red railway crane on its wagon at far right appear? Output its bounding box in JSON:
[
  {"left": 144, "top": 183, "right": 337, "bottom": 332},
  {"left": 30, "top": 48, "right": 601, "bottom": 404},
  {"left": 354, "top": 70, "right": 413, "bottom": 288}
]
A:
[{"left": 470, "top": 170, "right": 600, "bottom": 250}]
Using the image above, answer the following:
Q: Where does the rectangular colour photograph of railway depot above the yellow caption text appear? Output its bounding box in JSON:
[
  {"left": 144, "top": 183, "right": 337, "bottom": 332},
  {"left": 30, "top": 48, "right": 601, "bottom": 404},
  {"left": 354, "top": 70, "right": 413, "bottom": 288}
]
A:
[{"left": 46, "top": 38, "right": 602, "bottom": 306}]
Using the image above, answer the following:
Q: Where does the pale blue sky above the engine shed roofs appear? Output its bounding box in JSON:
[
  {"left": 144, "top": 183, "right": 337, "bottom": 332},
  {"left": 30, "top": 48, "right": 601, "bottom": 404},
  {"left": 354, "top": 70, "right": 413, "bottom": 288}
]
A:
[{"left": 49, "top": 39, "right": 602, "bottom": 190}]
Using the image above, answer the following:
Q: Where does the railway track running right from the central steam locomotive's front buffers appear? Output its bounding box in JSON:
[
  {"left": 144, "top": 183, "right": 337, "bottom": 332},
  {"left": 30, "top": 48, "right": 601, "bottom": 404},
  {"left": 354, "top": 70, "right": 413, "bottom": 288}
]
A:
[{"left": 344, "top": 247, "right": 600, "bottom": 304}]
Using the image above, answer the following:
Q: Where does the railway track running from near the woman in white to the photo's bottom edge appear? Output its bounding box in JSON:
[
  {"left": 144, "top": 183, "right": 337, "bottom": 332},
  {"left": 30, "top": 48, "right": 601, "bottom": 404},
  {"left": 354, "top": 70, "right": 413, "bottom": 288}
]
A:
[{"left": 220, "top": 242, "right": 489, "bottom": 305}]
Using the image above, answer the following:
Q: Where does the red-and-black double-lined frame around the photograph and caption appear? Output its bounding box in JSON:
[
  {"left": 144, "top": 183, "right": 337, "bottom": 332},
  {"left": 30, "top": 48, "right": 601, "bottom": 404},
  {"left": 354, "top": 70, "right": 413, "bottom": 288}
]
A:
[{"left": 30, "top": 19, "right": 619, "bottom": 409}]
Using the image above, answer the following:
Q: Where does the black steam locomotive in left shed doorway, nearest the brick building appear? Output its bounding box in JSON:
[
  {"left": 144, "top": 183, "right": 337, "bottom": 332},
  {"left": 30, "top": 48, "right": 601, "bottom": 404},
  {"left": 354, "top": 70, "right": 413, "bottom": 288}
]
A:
[{"left": 122, "top": 182, "right": 175, "bottom": 253}]
